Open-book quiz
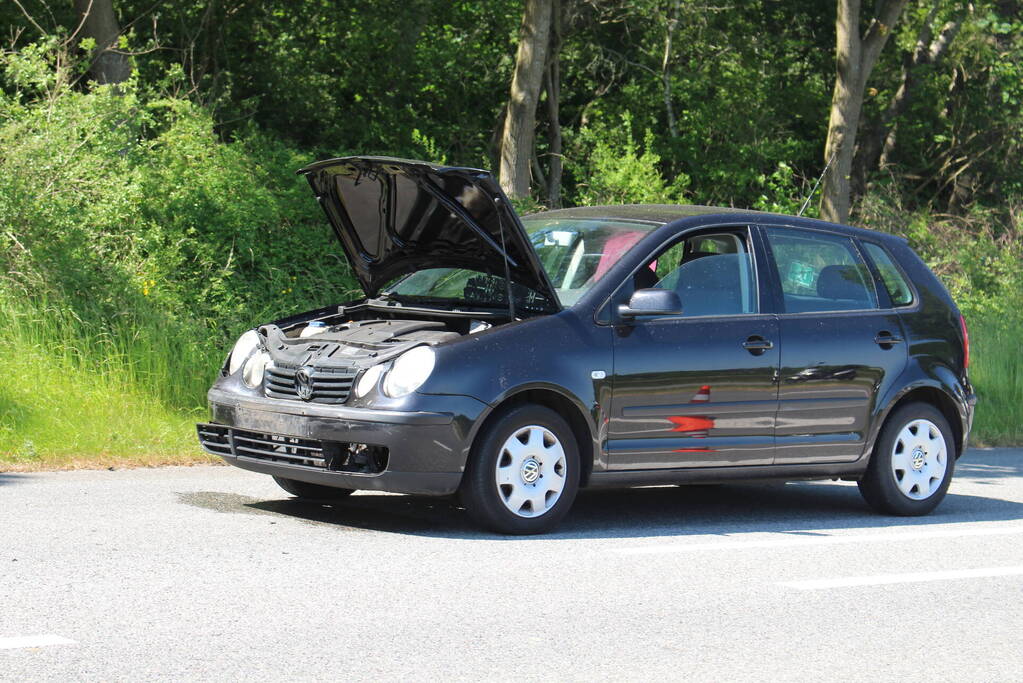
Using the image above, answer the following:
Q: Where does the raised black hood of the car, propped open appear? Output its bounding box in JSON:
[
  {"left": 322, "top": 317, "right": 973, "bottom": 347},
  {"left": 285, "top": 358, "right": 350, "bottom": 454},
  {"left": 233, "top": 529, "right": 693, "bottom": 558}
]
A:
[{"left": 299, "top": 156, "right": 559, "bottom": 310}]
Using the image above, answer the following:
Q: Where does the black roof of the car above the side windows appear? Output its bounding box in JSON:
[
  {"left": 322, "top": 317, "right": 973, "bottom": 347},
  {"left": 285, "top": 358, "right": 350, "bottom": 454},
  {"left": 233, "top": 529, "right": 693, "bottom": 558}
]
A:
[{"left": 523, "top": 203, "right": 904, "bottom": 241}]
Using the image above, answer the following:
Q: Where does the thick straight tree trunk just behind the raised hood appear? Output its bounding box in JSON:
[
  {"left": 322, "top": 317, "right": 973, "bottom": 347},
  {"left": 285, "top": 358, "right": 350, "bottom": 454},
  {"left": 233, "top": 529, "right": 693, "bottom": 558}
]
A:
[{"left": 500, "top": 0, "right": 552, "bottom": 197}]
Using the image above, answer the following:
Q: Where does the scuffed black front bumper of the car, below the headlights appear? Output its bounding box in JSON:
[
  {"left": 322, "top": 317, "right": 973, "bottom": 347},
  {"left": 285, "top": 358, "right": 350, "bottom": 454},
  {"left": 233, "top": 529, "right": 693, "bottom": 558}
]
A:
[{"left": 198, "top": 389, "right": 487, "bottom": 495}]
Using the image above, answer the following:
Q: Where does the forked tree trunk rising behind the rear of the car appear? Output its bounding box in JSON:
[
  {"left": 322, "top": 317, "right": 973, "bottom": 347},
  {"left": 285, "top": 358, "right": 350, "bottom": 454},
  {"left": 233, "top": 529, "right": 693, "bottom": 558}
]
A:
[{"left": 820, "top": 0, "right": 907, "bottom": 223}]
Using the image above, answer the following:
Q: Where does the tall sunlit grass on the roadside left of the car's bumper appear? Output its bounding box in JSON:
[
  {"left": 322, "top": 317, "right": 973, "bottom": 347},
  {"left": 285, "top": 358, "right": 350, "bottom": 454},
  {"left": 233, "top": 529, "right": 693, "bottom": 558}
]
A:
[{"left": 0, "top": 292, "right": 217, "bottom": 469}]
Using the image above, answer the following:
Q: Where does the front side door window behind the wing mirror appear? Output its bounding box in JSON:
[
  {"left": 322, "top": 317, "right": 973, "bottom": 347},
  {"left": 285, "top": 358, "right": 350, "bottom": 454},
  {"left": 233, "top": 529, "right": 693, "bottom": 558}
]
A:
[{"left": 651, "top": 233, "right": 757, "bottom": 318}]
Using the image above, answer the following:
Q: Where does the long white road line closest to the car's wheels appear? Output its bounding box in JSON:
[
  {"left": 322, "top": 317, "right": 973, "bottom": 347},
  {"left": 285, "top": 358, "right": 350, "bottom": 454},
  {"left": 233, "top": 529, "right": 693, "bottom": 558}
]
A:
[{"left": 612, "top": 527, "right": 1023, "bottom": 555}]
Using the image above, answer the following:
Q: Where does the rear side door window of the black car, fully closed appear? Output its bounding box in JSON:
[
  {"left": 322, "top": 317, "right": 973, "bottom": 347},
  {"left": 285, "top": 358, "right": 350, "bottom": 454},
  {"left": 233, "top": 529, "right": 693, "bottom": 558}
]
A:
[{"left": 767, "top": 228, "right": 878, "bottom": 313}]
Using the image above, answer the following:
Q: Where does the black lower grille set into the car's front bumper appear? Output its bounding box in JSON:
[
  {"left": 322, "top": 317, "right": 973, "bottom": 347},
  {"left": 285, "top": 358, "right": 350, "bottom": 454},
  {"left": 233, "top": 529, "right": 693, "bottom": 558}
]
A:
[{"left": 195, "top": 424, "right": 388, "bottom": 474}]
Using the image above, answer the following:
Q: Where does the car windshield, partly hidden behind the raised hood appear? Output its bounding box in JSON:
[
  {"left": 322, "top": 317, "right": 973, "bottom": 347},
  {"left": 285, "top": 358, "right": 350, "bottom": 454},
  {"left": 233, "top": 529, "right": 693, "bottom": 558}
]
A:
[{"left": 389, "top": 214, "right": 657, "bottom": 308}]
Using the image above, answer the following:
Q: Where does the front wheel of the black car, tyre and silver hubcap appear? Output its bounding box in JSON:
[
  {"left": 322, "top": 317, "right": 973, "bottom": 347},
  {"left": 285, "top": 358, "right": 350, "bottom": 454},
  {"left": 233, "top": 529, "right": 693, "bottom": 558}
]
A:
[{"left": 461, "top": 405, "right": 579, "bottom": 534}]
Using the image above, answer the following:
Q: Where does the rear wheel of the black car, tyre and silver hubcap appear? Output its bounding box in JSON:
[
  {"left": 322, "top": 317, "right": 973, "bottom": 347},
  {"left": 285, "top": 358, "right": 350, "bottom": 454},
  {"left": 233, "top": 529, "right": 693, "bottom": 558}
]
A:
[{"left": 858, "top": 403, "right": 955, "bottom": 516}]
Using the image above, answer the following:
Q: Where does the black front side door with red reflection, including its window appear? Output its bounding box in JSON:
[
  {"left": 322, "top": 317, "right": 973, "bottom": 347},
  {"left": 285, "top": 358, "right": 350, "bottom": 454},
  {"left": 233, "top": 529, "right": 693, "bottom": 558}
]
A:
[{"left": 607, "top": 228, "right": 780, "bottom": 469}]
